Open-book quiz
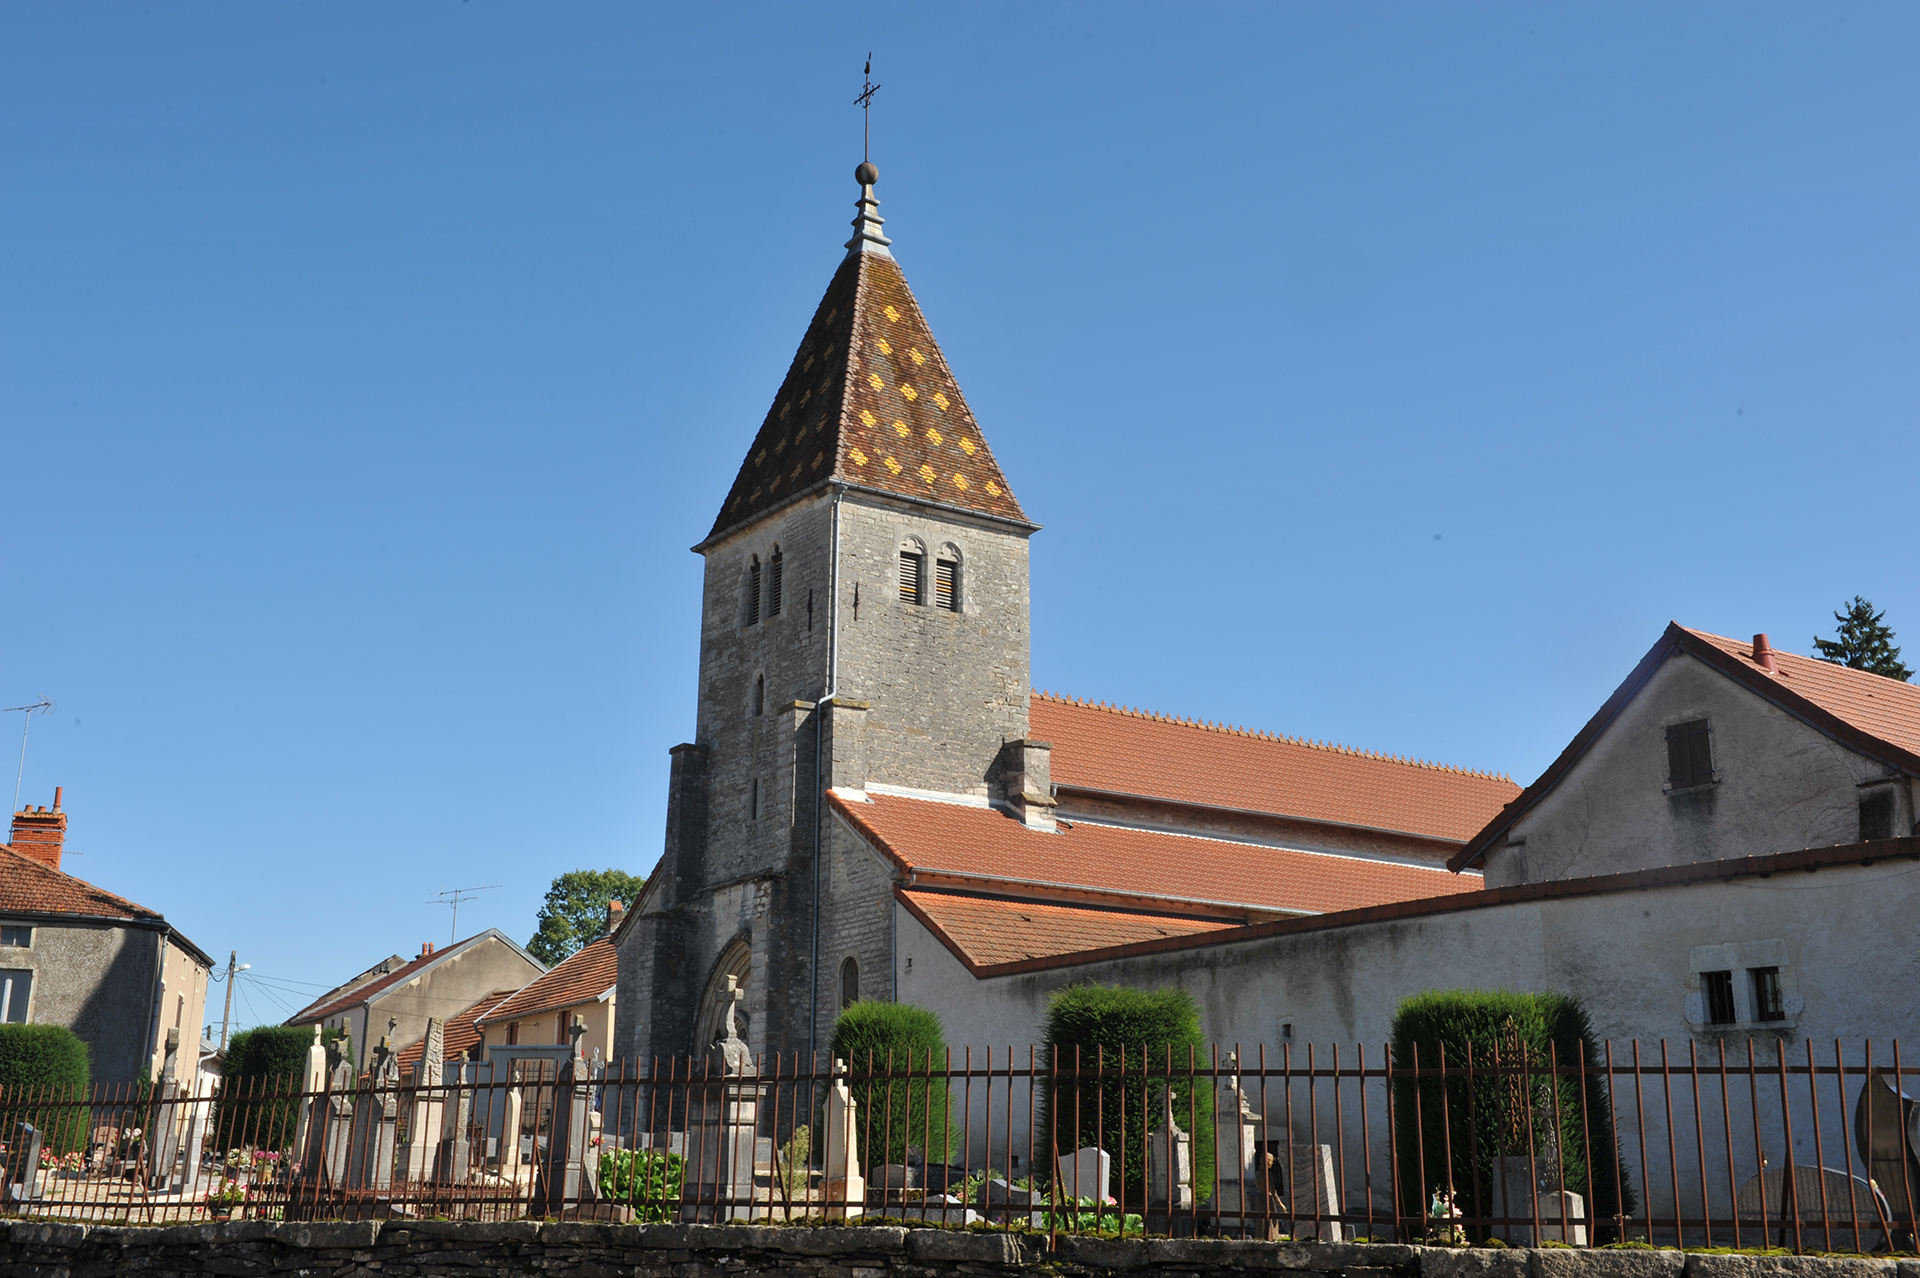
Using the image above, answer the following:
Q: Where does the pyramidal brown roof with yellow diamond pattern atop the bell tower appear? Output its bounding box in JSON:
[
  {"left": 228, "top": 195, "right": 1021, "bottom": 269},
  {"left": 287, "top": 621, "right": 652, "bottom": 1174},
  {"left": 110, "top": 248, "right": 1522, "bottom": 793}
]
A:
[{"left": 707, "top": 223, "right": 1027, "bottom": 539}]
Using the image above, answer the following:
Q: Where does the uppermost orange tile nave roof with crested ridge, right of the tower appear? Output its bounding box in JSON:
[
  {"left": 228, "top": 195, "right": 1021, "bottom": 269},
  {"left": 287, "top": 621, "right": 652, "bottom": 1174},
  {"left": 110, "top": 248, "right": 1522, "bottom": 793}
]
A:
[{"left": 1027, "top": 693, "right": 1521, "bottom": 842}]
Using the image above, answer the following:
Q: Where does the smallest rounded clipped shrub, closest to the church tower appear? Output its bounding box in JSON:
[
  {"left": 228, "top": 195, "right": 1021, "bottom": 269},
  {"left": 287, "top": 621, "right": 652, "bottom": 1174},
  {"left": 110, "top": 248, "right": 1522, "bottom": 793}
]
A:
[{"left": 831, "top": 1000, "right": 952, "bottom": 1163}]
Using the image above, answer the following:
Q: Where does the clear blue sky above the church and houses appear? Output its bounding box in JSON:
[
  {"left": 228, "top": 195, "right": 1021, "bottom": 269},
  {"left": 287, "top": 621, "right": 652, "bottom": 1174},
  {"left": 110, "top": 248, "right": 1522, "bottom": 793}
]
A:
[{"left": 0, "top": 0, "right": 1920, "bottom": 1023}]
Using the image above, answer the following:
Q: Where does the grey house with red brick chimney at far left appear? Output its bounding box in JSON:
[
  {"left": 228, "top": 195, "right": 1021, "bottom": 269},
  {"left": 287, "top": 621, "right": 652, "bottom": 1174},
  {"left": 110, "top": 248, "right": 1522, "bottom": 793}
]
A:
[{"left": 0, "top": 789, "right": 213, "bottom": 1082}]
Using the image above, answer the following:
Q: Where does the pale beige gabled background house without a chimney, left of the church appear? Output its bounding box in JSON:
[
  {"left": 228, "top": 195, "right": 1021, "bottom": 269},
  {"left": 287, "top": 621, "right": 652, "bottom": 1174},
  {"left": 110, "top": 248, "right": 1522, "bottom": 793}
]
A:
[{"left": 286, "top": 927, "right": 547, "bottom": 1067}]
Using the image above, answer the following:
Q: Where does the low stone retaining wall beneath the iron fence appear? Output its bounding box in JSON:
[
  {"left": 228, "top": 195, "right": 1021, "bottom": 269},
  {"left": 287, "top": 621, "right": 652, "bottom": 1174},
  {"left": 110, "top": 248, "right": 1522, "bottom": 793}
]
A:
[{"left": 0, "top": 1220, "right": 1920, "bottom": 1278}]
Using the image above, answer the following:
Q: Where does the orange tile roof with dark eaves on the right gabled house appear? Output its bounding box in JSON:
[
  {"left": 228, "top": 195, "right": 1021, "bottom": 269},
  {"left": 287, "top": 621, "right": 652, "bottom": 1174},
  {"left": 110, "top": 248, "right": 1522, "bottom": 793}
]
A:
[{"left": 1448, "top": 622, "right": 1920, "bottom": 869}]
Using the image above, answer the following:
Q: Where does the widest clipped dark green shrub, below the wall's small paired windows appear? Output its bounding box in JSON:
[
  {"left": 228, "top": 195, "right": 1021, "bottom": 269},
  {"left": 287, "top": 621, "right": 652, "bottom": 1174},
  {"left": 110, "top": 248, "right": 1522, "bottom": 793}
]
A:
[{"left": 1394, "top": 990, "right": 1636, "bottom": 1242}]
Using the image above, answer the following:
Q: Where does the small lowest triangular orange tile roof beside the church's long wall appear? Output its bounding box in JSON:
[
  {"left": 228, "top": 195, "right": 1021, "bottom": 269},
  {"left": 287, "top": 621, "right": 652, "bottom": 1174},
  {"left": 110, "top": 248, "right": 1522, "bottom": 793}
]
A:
[{"left": 897, "top": 888, "right": 1236, "bottom": 965}]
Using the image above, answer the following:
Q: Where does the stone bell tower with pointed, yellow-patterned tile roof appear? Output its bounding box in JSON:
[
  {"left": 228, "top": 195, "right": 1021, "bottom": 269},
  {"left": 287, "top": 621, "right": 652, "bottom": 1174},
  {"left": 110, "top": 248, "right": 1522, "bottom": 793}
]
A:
[{"left": 616, "top": 163, "right": 1037, "bottom": 1055}]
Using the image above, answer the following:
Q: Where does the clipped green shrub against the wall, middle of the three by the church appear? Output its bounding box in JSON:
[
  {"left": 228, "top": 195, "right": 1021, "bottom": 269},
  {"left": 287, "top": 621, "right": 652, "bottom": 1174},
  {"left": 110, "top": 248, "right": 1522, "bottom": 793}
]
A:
[{"left": 1033, "top": 984, "right": 1215, "bottom": 1203}]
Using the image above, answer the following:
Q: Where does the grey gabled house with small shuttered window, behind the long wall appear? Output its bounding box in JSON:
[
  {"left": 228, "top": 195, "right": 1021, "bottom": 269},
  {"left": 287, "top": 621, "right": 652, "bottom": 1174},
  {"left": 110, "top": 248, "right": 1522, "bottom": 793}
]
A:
[{"left": 1450, "top": 622, "right": 1920, "bottom": 885}]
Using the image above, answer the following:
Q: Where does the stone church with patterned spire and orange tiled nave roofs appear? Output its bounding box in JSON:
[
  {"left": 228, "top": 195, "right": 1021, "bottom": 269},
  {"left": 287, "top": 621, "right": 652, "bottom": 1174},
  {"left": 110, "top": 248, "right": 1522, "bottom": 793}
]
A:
[{"left": 614, "top": 163, "right": 1519, "bottom": 1059}]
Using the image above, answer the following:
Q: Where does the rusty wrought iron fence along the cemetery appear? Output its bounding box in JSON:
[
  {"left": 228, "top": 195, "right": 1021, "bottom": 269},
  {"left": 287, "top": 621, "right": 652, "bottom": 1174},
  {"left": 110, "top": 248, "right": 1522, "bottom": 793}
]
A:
[{"left": 0, "top": 1038, "right": 1920, "bottom": 1251}]
